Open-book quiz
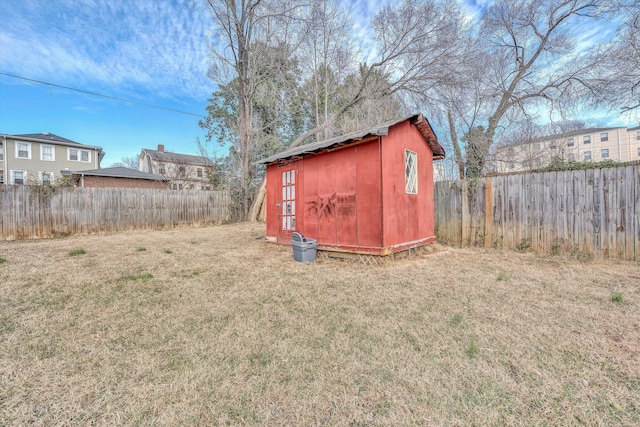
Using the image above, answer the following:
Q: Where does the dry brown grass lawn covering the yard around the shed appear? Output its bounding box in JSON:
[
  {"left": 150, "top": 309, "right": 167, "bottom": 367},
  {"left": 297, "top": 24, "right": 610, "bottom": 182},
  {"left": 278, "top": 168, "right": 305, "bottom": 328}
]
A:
[{"left": 0, "top": 224, "right": 640, "bottom": 426}]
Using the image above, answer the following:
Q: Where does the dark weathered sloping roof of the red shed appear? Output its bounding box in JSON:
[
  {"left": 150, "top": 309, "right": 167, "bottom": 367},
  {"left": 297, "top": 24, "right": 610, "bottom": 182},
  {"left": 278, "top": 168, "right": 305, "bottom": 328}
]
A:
[{"left": 256, "top": 113, "right": 445, "bottom": 164}]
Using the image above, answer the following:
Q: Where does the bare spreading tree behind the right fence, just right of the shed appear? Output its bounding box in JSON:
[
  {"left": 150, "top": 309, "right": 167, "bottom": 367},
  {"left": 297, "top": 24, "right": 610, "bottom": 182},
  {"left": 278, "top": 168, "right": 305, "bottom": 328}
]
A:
[{"left": 444, "top": 0, "right": 613, "bottom": 177}]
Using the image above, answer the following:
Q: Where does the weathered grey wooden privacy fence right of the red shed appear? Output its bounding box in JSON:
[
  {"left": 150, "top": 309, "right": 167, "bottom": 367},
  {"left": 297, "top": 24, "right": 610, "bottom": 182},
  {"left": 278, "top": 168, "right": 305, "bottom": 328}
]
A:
[{"left": 435, "top": 165, "right": 640, "bottom": 261}]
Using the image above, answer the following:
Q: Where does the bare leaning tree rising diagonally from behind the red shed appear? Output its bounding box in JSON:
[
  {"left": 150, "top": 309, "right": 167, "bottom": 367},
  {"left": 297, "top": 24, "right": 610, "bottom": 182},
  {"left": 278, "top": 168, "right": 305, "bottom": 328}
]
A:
[{"left": 249, "top": 0, "right": 463, "bottom": 220}]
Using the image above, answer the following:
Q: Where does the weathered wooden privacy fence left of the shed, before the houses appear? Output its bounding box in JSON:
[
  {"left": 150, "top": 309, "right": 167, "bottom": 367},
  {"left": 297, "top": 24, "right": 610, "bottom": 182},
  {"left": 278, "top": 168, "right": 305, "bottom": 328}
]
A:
[{"left": 0, "top": 185, "right": 230, "bottom": 240}]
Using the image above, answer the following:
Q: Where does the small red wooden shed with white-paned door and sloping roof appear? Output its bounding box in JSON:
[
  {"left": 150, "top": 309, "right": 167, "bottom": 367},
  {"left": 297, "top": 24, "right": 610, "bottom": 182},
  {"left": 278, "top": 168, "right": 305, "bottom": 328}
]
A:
[{"left": 259, "top": 114, "right": 445, "bottom": 255}]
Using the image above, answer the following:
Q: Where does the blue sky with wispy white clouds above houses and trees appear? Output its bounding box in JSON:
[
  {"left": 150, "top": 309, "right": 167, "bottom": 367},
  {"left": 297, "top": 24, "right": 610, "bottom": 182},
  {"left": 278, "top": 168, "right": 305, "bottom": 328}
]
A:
[{"left": 0, "top": 0, "right": 626, "bottom": 167}]
